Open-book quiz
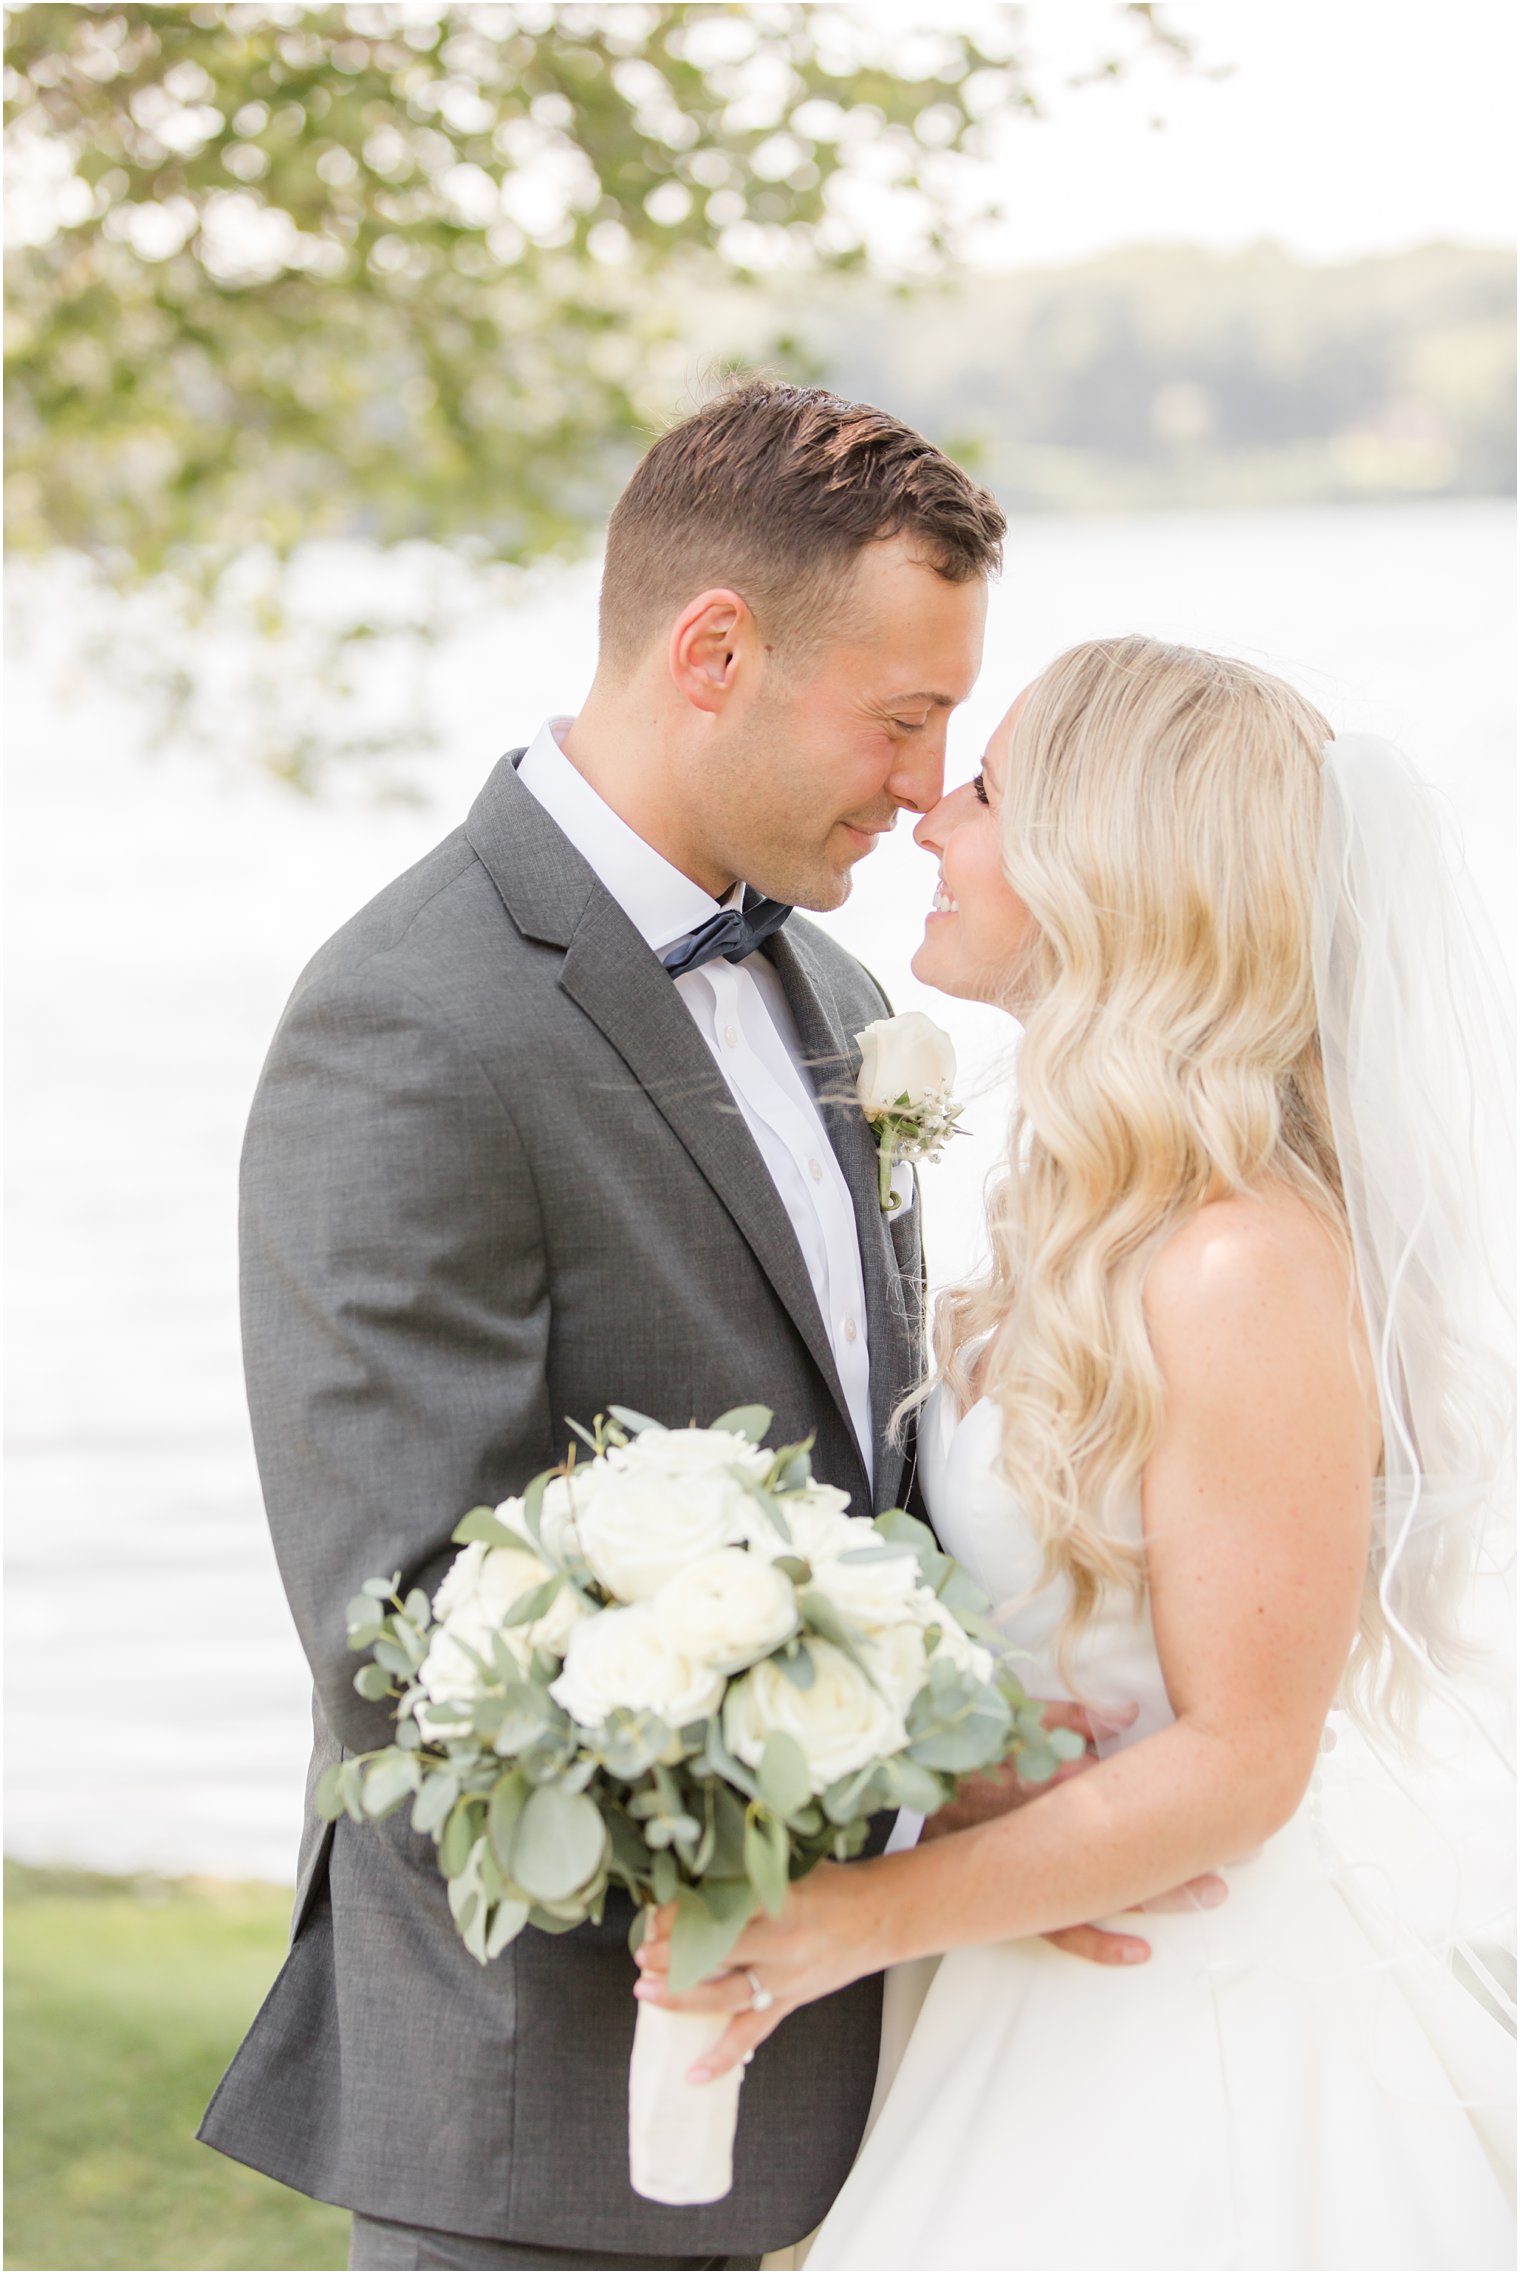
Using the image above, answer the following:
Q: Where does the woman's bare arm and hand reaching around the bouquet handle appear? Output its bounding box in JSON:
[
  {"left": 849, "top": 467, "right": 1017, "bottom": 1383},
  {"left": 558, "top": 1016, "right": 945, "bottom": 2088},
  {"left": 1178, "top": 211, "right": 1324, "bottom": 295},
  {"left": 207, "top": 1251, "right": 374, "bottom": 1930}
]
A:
[{"left": 639, "top": 1198, "right": 1377, "bottom": 2069}]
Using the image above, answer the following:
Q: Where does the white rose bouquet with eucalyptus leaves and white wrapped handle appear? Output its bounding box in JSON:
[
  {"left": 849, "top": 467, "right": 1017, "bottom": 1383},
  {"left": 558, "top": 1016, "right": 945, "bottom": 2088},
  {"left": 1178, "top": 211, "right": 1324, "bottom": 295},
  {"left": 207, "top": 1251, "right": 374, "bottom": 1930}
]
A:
[{"left": 316, "top": 1405, "right": 1081, "bottom": 2204}]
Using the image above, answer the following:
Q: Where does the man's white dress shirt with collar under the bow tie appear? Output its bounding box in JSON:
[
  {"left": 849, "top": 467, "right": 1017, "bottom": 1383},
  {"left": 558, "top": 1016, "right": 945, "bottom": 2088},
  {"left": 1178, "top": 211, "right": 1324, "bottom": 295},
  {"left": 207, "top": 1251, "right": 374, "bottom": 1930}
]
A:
[{"left": 517, "top": 719, "right": 874, "bottom": 1482}]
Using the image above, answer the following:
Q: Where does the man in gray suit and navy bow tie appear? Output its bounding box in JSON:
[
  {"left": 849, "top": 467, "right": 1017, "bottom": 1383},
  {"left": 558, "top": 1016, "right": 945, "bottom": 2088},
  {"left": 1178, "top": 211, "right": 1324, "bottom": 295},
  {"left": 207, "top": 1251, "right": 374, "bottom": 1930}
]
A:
[{"left": 200, "top": 382, "right": 1133, "bottom": 2267}]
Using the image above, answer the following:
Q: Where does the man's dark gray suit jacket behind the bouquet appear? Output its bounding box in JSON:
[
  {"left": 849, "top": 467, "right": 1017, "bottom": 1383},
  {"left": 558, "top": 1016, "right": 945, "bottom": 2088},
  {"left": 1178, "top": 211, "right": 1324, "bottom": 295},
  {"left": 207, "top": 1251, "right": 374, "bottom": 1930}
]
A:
[{"left": 200, "top": 760, "right": 922, "bottom": 2256}]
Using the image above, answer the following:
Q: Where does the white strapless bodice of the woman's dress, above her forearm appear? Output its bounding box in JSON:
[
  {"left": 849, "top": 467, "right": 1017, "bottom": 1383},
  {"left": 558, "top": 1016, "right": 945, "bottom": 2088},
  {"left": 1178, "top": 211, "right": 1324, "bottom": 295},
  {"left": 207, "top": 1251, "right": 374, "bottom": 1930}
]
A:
[{"left": 919, "top": 1387, "right": 1174, "bottom": 1742}]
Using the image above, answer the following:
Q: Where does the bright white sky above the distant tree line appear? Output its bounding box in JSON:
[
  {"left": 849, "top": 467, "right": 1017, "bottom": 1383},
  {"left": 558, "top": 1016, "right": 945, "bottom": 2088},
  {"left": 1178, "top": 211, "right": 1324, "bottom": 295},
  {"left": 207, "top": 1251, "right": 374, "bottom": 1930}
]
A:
[{"left": 955, "top": 0, "right": 1520, "bottom": 268}]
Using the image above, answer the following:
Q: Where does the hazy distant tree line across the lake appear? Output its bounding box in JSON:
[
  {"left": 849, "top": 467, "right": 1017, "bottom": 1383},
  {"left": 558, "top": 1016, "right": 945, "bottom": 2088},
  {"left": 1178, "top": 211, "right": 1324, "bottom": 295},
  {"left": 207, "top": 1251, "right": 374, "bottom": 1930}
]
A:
[{"left": 764, "top": 246, "right": 1515, "bottom": 512}]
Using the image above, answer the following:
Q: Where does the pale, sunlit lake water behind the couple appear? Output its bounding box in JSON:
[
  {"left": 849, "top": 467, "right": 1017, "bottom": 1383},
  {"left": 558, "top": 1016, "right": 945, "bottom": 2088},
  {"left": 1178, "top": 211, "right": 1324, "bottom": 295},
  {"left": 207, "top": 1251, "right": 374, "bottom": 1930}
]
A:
[{"left": 7, "top": 503, "right": 1515, "bottom": 1878}]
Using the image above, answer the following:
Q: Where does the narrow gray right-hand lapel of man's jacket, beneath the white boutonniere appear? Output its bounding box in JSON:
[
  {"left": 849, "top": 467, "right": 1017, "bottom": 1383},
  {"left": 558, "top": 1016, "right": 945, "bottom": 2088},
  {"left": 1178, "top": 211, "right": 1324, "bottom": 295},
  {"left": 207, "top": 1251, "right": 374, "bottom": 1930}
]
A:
[{"left": 762, "top": 923, "right": 922, "bottom": 1508}]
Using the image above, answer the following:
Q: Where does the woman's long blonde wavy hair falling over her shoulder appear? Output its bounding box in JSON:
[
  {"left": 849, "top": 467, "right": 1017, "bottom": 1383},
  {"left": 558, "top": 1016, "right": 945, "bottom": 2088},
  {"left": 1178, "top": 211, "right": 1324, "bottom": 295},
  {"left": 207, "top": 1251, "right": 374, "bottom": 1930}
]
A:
[{"left": 917, "top": 637, "right": 1428, "bottom": 1701}]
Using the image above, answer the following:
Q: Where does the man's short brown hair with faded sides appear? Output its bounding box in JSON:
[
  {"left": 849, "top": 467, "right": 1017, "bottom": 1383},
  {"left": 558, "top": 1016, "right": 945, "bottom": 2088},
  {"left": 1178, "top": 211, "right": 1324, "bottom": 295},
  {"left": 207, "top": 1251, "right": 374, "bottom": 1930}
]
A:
[{"left": 601, "top": 380, "right": 1008, "bottom": 669}]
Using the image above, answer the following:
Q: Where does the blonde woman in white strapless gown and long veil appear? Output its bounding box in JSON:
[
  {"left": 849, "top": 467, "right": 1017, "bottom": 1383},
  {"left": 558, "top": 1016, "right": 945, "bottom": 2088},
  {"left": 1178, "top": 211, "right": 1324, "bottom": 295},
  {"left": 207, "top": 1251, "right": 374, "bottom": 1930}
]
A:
[{"left": 639, "top": 639, "right": 1513, "bottom": 2267}]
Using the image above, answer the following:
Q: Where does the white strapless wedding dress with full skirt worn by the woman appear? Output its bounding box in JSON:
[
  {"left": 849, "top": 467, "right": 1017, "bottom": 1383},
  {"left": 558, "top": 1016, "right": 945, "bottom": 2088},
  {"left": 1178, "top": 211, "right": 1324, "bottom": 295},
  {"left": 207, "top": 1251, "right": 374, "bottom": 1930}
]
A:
[{"left": 808, "top": 1389, "right": 1515, "bottom": 2274}]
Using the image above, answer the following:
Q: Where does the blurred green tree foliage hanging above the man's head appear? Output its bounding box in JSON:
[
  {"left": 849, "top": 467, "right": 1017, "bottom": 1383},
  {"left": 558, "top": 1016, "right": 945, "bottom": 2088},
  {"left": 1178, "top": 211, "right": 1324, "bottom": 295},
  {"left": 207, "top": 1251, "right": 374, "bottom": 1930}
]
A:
[{"left": 7, "top": 0, "right": 1179, "bottom": 775}]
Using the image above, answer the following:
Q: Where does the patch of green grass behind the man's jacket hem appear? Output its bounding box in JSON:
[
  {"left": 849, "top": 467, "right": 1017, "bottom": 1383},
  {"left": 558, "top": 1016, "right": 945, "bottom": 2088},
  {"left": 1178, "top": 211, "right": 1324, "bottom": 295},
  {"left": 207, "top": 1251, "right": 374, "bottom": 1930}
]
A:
[{"left": 5, "top": 1862, "right": 348, "bottom": 2269}]
